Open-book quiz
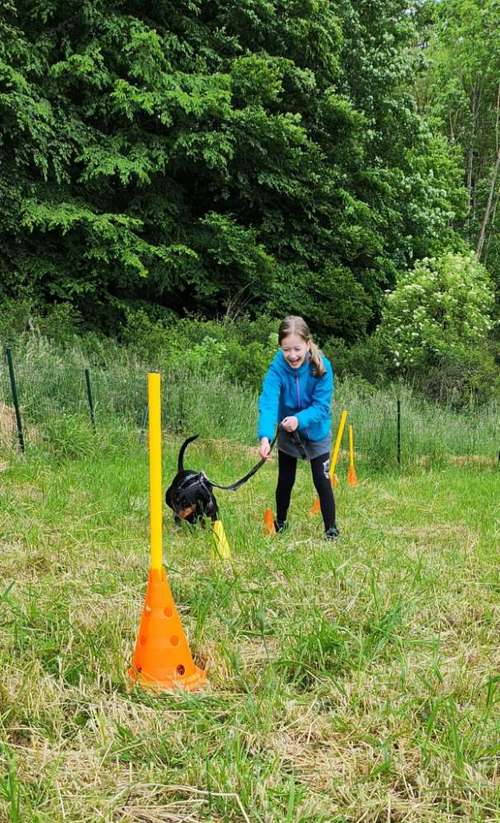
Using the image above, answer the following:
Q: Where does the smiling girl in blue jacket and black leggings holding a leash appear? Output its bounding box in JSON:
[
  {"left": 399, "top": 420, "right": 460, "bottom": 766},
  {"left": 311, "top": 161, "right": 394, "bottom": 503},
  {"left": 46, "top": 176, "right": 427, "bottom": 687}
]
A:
[{"left": 258, "top": 315, "right": 339, "bottom": 540}]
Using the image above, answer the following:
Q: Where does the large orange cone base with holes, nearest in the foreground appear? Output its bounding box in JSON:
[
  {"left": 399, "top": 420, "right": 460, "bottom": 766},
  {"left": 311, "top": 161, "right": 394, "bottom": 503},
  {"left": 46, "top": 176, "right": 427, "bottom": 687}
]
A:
[{"left": 129, "top": 568, "right": 206, "bottom": 691}]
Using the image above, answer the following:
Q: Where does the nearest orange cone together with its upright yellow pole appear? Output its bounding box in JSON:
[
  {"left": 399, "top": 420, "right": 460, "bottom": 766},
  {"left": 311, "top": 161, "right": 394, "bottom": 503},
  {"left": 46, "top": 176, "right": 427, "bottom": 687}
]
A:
[{"left": 129, "top": 372, "right": 206, "bottom": 691}]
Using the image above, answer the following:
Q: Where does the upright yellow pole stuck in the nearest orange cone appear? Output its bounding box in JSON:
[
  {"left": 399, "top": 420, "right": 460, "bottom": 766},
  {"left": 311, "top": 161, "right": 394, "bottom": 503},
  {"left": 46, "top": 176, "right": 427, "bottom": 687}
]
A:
[{"left": 148, "top": 372, "right": 163, "bottom": 570}]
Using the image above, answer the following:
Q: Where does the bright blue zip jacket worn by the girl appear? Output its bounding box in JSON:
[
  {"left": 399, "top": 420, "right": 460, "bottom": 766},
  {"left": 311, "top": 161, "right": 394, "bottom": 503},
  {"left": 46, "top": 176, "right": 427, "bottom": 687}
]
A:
[{"left": 258, "top": 349, "right": 334, "bottom": 440}]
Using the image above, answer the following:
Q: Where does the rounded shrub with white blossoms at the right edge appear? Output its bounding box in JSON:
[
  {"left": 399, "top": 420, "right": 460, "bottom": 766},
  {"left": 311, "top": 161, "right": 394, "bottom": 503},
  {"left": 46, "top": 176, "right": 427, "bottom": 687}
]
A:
[{"left": 379, "top": 252, "right": 494, "bottom": 369}]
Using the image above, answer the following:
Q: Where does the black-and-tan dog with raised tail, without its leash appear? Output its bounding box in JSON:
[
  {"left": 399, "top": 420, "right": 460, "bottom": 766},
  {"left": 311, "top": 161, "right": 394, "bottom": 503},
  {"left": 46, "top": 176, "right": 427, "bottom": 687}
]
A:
[{"left": 165, "top": 437, "right": 217, "bottom": 523}]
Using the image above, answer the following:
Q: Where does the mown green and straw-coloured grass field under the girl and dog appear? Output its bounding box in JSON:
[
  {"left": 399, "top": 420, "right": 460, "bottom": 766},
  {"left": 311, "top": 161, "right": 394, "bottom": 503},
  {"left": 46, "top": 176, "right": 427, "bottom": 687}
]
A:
[{"left": 0, "top": 424, "right": 500, "bottom": 823}]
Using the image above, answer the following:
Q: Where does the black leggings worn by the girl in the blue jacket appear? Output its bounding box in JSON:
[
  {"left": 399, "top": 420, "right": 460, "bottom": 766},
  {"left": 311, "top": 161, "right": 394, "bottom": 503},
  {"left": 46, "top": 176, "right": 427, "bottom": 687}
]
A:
[{"left": 276, "top": 450, "right": 336, "bottom": 531}]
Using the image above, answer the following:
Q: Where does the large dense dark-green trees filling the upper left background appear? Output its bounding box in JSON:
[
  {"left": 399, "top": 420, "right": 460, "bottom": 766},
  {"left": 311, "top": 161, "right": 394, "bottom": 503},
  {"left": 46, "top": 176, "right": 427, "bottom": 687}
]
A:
[{"left": 0, "top": 0, "right": 461, "bottom": 341}]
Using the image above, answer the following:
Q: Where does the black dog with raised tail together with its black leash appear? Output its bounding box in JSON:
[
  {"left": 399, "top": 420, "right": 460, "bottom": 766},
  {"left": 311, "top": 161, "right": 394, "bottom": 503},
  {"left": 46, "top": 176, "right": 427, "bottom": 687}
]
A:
[{"left": 165, "top": 434, "right": 276, "bottom": 524}]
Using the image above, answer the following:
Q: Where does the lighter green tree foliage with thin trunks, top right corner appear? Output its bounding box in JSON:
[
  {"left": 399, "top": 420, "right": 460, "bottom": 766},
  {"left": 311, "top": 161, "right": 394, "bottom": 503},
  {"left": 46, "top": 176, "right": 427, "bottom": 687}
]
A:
[{"left": 417, "top": 0, "right": 500, "bottom": 287}]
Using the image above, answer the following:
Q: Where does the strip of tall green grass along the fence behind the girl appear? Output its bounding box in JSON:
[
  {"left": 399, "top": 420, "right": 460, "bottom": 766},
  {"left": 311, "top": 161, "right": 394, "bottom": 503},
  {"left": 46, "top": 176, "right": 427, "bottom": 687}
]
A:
[{"left": 0, "top": 335, "right": 498, "bottom": 470}]
